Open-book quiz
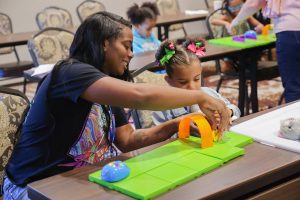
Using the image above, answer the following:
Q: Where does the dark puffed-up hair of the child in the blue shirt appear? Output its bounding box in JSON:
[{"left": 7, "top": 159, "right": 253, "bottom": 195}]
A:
[{"left": 127, "top": 2, "right": 159, "bottom": 25}]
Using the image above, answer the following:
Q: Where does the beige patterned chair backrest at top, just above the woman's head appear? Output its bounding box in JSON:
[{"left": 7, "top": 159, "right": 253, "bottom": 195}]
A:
[{"left": 76, "top": 0, "right": 106, "bottom": 22}]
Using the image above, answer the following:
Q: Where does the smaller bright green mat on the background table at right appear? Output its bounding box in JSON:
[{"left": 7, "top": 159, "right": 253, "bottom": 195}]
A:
[{"left": 208, "top": 34, "right": 276, "bottom": 49}]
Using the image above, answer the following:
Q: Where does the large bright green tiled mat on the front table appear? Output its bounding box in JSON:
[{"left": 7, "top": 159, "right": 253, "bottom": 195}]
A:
[{"left": 88, "top": 132, "right": 253, "bottom": 199}]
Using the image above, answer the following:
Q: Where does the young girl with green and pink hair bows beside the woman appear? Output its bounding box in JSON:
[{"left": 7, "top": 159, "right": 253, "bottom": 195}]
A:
[{"left": 152, "top": 39, "right": 241, "bottom": 125}]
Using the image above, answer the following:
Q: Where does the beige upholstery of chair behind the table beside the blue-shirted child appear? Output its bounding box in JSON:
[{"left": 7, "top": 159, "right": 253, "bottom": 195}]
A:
[{"left": 156, "top": 0, "right": 184, "bottom": 31}]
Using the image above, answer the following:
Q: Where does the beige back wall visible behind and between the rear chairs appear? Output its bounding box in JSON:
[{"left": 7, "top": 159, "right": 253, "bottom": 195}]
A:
[{"left": 0, "top": 0, "right": 212, "bottom": 63}]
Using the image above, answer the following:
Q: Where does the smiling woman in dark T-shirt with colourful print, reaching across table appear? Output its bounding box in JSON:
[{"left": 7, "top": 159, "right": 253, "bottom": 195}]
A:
[{"left": 3, "top": 12, "right": 229, "bottom": 200}]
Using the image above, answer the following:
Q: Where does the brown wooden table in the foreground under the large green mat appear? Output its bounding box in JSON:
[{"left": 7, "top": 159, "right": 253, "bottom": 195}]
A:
[{"left": 28, "top": 104, "right": 300, "bottom": 200}]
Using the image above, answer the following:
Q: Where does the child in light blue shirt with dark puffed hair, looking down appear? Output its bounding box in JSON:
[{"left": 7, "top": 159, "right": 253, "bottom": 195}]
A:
[{"left": 127, "top": 2, "right": 160, "bottom": 54}]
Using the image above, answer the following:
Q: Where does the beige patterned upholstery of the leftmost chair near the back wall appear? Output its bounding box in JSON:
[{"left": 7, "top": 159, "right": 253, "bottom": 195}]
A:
[{"left": 0, "top": 13, "right": 13, "bottom": 54}]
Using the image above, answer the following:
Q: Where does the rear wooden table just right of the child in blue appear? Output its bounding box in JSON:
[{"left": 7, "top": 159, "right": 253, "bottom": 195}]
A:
[{"left": 155, "top": 13, "right": 208, "bottom": 41}]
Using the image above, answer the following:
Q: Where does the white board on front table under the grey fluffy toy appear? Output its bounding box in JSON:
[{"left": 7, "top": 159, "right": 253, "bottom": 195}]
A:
[{"left": 230, "top": 102, "right": 300, "bottom": 153}]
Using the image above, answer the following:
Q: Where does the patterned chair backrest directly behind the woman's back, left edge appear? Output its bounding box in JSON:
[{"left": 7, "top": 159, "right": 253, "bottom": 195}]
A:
[{"left": 0, "top": 87, "right": 29, "bottom": 188}]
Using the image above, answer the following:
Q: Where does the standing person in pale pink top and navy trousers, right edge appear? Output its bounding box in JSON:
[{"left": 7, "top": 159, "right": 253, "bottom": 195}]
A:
[{"left": 229, "top": 0, "right": 300, "bottom": 102}]
